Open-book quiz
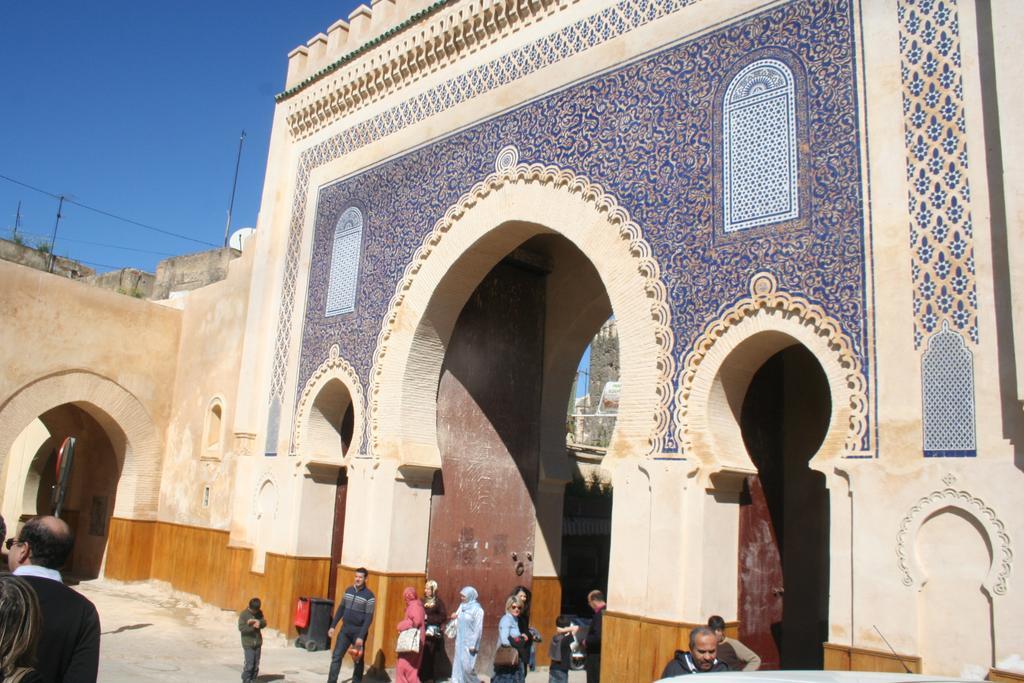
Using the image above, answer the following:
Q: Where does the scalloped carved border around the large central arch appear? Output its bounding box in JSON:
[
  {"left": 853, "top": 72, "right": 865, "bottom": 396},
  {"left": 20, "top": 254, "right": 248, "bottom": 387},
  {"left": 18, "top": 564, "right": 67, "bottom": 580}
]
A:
[{"left": 370, "top": 146, "right": 675, "bottom": 454}]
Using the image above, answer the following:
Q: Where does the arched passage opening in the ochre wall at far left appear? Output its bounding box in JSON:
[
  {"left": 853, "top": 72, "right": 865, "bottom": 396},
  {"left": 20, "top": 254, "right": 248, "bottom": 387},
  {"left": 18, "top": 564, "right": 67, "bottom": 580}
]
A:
[{"left": 8, "top": 403, "right": 124, "bottom": 579}]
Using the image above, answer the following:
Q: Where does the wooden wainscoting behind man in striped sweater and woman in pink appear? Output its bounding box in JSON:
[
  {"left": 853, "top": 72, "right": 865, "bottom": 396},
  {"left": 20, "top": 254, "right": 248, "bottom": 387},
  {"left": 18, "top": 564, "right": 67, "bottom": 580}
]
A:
[{"left": 332, "top": 565, "right": 427, "bottom": 673}]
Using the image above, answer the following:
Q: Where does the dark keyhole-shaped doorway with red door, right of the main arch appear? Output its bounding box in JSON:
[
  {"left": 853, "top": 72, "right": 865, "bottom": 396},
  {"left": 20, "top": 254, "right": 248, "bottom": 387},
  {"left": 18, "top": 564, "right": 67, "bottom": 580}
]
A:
[{"left": 737, "top": 336, "right": 831, "bottom": 669}]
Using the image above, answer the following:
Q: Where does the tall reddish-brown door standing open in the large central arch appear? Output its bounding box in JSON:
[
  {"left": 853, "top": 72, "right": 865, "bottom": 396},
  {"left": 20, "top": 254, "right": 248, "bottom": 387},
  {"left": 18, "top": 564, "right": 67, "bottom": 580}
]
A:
[{"left": 427, "top": 263, "right": 545, "bottom": 673}]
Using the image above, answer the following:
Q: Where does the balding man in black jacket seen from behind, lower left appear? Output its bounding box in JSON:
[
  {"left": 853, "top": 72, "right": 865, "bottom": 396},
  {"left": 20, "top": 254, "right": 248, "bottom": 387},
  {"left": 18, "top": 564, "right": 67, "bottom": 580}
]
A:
[{"left": 7, "top": 517, "right": 99, "bottom": 683}]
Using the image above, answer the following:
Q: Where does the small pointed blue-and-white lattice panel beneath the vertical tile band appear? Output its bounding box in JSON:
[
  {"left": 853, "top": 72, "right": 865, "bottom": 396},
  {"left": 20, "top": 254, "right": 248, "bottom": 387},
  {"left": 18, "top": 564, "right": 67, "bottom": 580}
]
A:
[{"left": 921, "top": 322, "right": 977, "bottom": 458}]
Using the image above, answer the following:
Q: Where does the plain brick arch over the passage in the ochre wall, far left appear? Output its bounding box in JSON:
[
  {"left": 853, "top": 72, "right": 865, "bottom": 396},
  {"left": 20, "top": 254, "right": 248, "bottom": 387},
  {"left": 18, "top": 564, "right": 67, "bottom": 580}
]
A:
[{"left": 0, "top": 370, "right": 162, "bottom": 519}]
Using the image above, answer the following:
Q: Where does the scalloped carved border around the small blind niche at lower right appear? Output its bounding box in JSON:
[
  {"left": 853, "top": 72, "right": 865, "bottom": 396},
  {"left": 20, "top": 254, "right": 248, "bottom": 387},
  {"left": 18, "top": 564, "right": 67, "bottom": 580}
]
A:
[{"left": 896, "top": 487, "right": 1014, "bottom": 595}]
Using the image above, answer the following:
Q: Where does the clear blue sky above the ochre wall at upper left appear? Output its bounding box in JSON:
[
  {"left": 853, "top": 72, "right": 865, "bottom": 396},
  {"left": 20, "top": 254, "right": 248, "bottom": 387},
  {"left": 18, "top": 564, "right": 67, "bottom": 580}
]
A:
[{"left": 0, "top": 0, "right": 368, "bottom": 271}]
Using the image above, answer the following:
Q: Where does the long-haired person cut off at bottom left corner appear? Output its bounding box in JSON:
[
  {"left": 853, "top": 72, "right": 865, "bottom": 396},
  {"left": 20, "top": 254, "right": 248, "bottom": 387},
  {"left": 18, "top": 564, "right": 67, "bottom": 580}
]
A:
[{"left": 0, "top": 575, "right": 43, "bottom": 683}]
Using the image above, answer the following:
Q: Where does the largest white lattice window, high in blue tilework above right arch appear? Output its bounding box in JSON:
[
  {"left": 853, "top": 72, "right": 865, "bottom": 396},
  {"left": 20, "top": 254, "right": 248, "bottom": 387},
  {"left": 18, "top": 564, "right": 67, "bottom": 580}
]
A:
[{"left": 722, "top": 59, "right": 800, "bottom": 232}]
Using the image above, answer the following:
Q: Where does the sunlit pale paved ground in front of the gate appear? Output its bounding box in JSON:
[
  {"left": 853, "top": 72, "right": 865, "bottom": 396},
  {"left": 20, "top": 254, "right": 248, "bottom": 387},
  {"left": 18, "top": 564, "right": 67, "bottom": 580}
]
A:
[{"left": 76, "top": 580, "right": 586, "bottom": 683}]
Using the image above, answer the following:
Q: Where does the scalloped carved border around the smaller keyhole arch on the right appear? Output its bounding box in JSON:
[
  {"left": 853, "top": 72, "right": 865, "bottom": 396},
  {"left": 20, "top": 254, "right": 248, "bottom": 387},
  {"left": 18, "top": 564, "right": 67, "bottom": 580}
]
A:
[{"left": 676, "top": 272, "right": 868, "bottom": 455}]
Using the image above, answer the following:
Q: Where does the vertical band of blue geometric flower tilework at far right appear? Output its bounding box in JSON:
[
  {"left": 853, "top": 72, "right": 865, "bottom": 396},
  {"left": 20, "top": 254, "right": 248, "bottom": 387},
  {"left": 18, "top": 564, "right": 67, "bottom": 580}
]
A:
[{"left": 897, "top": 0, "right": 978, "bottom": 348}]
